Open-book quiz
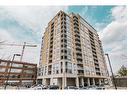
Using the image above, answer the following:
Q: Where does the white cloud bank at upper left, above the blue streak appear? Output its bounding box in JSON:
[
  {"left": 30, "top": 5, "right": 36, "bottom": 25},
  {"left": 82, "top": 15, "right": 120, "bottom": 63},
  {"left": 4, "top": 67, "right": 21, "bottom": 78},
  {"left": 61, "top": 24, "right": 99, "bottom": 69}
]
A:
[{"left": 0, "top": 6, "right": 68, "bottom": 42}]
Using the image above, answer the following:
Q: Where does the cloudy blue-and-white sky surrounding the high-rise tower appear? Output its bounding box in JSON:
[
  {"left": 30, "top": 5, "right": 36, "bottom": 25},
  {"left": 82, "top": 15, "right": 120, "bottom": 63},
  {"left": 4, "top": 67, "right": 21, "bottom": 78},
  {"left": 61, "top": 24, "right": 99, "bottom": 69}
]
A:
[{"left": 0, "top": 6, "right": 127, "bottom": 72}]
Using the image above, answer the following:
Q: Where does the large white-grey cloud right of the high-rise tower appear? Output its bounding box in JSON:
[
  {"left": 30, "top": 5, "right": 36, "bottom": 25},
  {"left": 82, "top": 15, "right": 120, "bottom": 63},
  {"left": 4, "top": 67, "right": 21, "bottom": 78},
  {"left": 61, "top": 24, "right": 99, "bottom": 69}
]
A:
[{"left": 99, "top": 6, "right": 127, "bottom": 72}]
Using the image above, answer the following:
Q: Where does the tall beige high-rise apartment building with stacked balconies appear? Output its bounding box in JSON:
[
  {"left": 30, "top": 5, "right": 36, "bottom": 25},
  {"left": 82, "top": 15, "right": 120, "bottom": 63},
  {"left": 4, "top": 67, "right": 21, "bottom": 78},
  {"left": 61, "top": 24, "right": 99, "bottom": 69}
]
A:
[{"left": 37, "top": 11, "right": 108, "bottom": 88}]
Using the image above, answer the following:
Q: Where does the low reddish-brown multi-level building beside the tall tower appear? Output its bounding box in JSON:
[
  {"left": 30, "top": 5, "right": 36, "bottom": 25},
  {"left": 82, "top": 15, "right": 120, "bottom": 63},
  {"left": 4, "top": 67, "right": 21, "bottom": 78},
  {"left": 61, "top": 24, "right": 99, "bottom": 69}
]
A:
[{"left": 0, "top": 59, "right": 37, "bottom": 86}]
